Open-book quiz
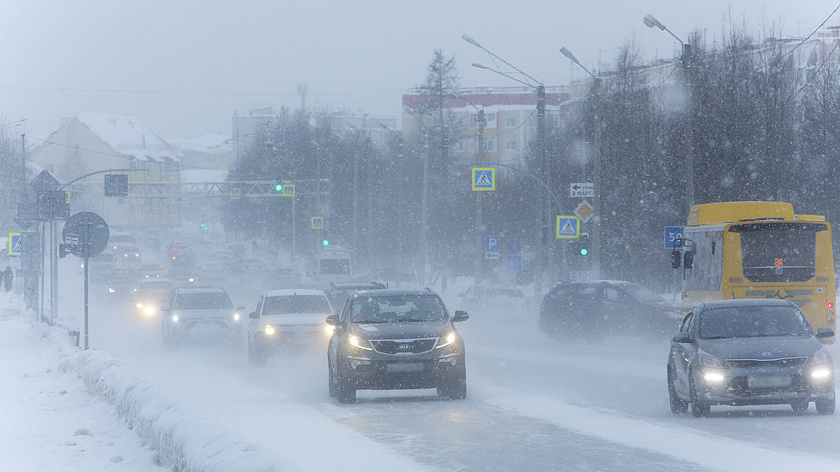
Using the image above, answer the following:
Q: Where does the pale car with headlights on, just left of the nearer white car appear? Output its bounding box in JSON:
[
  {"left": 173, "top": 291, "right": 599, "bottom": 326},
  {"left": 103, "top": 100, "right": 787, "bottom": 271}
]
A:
[{"left": 160, "top": 287, "right": 245, "bottom": 347}]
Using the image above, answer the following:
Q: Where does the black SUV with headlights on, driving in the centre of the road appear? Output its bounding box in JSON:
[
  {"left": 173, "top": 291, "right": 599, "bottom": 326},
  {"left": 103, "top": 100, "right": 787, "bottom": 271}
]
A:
[{"left": 327, "top": 290, "right": 469, "bottom": 403}]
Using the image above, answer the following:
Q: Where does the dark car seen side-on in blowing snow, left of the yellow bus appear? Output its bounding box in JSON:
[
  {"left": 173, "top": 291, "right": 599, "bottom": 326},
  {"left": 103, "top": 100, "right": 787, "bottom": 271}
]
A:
[{"left": 539, "top": 280, "right": 681, "bottom": 342}]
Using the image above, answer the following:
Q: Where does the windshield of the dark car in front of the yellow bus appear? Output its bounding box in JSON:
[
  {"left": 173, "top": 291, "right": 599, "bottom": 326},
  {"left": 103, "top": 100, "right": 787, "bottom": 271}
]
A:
[{"left": 698, "top": 306, "right": 813, "bottom": 339}]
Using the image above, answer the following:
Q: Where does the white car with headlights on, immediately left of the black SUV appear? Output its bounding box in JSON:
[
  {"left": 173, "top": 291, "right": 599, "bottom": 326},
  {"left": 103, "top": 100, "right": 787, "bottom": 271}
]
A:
[{"left": 248, "top": 289, "right": 333, "bottom": 364}]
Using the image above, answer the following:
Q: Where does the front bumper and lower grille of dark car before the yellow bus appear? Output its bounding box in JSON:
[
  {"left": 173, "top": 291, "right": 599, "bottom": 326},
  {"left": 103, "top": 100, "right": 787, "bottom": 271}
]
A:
[{"left": 694, "top": 361, "right": 834, "bottom": 406}]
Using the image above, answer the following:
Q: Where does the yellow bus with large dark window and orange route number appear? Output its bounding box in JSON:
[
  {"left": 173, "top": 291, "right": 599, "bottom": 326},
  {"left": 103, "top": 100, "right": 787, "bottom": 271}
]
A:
[{"left": 672, "top": 202, "right": 836, "bottom": 342}]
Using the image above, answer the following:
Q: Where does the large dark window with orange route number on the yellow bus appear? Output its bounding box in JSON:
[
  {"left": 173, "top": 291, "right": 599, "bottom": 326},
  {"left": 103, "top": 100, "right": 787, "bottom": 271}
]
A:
[{"left": 729, "top": 222, "right": 827, "bottom": 282}]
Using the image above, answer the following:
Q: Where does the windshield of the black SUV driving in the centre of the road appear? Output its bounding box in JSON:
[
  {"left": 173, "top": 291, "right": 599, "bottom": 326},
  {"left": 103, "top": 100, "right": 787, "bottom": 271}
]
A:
[{"left": 350, "top": 295, "right": 447, "bottom": 323}]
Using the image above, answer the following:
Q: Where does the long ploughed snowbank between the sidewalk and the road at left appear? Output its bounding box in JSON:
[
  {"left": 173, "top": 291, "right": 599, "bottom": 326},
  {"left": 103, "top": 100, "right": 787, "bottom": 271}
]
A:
[{"left": 59, "top": 351, "right": 293, "bottom": 472}]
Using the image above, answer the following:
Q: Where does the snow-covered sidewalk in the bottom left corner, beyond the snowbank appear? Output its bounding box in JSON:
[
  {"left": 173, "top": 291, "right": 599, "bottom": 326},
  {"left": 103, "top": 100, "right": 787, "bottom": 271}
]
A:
[{"left": 0, "top": 293, "right": 165, "bottom": 472}]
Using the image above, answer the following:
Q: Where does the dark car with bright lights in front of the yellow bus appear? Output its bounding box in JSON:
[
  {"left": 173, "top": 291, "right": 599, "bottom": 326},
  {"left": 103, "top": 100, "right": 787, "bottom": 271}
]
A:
[{"left": 667, "top": 299, "right": 834, "bottom": 416}]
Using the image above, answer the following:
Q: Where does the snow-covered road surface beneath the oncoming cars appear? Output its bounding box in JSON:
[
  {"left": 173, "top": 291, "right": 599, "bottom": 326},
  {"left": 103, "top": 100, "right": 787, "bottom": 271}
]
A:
[{"left": 11, "top": 264, "right": 840, "bottom": 471}]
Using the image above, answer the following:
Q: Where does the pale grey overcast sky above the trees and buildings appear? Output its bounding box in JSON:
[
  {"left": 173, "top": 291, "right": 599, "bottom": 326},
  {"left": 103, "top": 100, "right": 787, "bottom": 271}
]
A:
[{"left": 0, "top": 0, "right": 840, "bottom": 138}]
